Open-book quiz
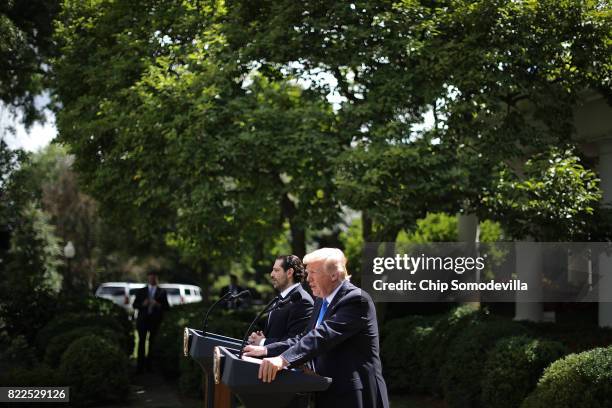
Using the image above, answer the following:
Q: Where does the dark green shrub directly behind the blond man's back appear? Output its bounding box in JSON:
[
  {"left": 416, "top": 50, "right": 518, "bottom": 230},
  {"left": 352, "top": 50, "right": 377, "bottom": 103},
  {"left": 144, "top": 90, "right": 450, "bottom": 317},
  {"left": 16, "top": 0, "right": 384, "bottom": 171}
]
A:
[{"left": 381, "top": 316, "right": 435, "bottom": 393}]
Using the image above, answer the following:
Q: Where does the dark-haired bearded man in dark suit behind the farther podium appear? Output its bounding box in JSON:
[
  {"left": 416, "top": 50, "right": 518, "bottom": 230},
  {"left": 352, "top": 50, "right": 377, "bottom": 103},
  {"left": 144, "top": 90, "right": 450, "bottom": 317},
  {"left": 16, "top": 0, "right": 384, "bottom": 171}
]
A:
[{"left": 249, "top": 255, "right": 314, "bottom": 346}]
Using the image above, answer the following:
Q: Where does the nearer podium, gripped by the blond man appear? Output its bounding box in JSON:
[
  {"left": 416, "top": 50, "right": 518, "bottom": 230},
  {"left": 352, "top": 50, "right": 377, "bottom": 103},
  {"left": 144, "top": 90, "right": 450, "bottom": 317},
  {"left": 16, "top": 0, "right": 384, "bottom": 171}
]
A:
[{"left": 214, "top": 346, "right": 332, "bottom": 408}]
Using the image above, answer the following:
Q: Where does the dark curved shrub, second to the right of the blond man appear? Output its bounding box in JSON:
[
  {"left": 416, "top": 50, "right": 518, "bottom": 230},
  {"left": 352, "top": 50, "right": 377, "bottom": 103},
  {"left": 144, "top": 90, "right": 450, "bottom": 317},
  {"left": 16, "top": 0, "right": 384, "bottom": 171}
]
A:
[{"left": 441, "top": 318, "right": 526, "bottom": 408}]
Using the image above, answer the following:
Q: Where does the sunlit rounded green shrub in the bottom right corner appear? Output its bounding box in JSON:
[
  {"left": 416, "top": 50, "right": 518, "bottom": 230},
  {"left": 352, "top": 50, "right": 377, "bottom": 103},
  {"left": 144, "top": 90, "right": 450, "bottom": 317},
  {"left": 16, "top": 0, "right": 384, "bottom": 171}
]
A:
[{"left": 521, "top": 347, "right": 612, "bottom": 408}]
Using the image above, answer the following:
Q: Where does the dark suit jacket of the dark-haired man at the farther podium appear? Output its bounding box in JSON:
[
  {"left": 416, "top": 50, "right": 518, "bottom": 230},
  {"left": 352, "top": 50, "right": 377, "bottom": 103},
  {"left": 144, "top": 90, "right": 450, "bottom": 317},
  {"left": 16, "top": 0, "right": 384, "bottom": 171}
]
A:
[{"left": 264, "top": 285, "right": 314, "bottom": 345}]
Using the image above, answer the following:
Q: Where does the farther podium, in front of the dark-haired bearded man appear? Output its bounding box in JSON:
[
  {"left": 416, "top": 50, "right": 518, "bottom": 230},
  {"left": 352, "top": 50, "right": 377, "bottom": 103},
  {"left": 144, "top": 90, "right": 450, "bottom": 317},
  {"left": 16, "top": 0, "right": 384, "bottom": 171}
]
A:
[{"left": 183, "top": 327, "right": 242, "bottom": 408}]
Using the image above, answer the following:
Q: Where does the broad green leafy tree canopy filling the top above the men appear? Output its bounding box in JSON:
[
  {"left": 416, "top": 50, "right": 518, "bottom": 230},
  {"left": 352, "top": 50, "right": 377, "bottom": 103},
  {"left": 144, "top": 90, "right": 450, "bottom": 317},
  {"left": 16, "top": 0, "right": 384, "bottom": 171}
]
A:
[{"left": 52, "top": 0, "right": 611, "bottom": 276}]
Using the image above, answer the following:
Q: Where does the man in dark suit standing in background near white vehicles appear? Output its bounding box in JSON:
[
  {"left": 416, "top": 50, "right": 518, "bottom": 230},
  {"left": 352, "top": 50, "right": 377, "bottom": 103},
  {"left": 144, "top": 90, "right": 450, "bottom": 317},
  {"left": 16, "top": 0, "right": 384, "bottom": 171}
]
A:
[{"left": 133, "top": 271, "right": 170, "bottom": 373}]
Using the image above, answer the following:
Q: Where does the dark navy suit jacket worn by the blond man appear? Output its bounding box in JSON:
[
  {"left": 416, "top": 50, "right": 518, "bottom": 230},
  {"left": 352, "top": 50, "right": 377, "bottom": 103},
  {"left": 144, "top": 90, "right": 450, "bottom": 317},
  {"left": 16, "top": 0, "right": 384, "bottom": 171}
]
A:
[{"left": 266, "top": 281, "right": 389, "bottom": 408}]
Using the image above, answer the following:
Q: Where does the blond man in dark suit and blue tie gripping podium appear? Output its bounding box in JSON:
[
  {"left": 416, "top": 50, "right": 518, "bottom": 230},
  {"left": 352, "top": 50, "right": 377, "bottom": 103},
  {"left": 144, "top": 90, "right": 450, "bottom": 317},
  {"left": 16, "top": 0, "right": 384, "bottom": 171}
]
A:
[{"left": 245, "top": 248, "right": 389, "bottom": 408}]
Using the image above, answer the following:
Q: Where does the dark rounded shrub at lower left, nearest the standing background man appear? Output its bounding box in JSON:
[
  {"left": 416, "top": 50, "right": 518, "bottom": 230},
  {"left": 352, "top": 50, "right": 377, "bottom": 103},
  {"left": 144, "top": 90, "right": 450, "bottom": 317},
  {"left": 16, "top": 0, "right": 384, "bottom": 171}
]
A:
[{"left": 59, "top": 335, "right": 129, "bottom": 406}]
